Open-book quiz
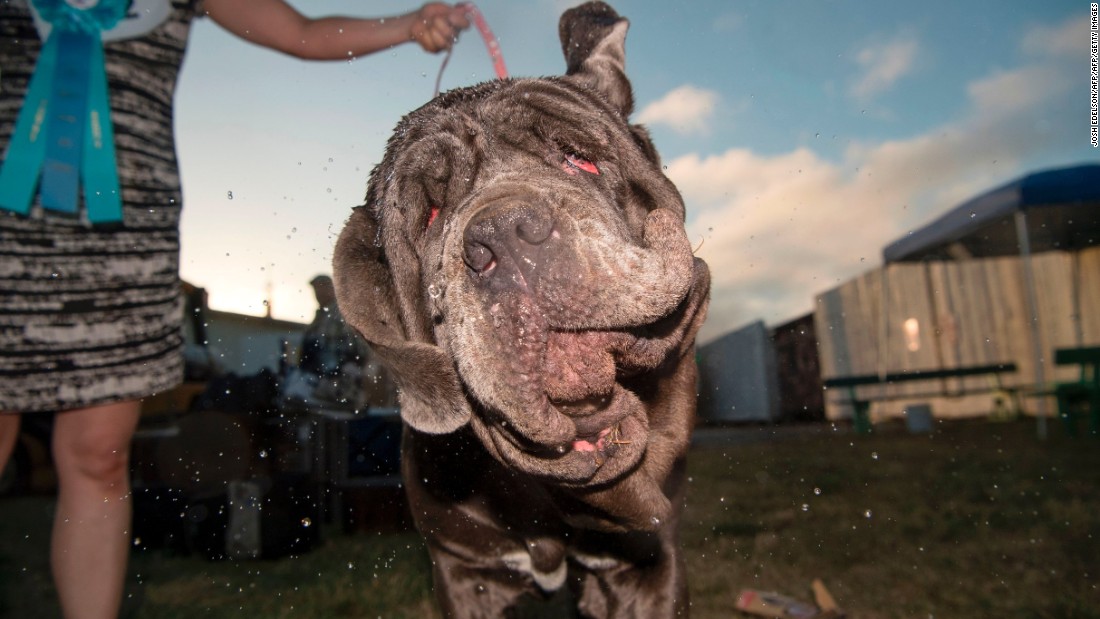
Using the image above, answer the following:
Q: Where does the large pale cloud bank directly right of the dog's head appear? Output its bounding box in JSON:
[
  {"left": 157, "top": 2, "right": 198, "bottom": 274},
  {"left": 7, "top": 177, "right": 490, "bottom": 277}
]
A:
[{"left": 668, "top": 29, "right": 1073, "bottom": 342}]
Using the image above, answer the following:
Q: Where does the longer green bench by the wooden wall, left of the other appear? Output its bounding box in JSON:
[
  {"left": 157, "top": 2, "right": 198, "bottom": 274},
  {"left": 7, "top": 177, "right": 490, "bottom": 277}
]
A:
[{"left": 825, "top": 362, "right": 1016, "bottom": 434}]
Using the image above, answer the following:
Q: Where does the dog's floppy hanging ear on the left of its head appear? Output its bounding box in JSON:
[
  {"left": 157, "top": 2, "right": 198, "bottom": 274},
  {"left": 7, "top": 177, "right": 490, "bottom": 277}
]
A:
[{"left": 332, "top": 207, "right": 471, "bottom": 434}]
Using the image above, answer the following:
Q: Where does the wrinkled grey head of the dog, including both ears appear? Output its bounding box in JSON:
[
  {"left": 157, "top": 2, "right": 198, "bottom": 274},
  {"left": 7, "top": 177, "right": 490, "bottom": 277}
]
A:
[{"left": 337, "top": 2, "right": 706, "bottom": 492}]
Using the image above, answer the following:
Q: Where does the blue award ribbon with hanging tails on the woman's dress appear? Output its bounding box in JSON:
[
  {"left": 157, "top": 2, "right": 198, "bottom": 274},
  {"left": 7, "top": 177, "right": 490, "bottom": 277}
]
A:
[{"left": 0, "top": 0, "right": 130, "bottom": 223}]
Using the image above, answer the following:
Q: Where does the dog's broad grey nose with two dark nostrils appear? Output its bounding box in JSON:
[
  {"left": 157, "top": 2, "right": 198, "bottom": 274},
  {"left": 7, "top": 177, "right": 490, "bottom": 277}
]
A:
[{"left": 463, "top": 199, "right": 553, "bottom": 287}]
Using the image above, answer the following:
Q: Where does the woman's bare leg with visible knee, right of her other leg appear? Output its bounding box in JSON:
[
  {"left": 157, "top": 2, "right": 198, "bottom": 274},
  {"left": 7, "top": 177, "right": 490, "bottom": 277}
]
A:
[{"left": 50, "top": 401, "right": 141, "bottom": 619}]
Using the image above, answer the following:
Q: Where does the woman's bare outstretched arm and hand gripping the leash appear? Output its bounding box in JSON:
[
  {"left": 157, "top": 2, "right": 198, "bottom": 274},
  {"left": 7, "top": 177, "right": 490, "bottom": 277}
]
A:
[{"left": 204, "top": 0, "right": 470, "bottom": 60}]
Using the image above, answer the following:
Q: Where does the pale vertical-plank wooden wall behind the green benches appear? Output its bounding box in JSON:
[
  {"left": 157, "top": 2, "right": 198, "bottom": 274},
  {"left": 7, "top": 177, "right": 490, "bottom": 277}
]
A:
[{"left": 814, "top": 247, "right": 1100, "bottom": 419}]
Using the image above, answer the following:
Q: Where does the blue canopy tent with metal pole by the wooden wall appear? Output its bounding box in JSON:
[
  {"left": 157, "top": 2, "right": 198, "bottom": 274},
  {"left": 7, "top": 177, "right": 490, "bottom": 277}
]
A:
[{"left": 882, "top": 164, "right": 1100, "bottom": 436}]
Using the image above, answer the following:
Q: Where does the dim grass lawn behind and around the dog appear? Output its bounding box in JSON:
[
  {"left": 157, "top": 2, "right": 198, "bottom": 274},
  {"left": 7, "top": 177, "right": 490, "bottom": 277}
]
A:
[{"left": 0, "top": 420, "right": 1100, "bottom": 619}]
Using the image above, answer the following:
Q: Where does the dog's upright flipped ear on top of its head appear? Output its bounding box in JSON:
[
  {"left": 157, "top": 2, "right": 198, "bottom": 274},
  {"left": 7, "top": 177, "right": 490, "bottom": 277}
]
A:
[{"left": 558, "top": 2, "right": 634, "bottom": 119}]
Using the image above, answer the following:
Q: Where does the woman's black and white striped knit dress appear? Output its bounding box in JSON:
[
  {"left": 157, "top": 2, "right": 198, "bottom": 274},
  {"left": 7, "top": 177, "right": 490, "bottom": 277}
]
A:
[{"left": 0, "top": 0, "right": 198, "bottom": 412}]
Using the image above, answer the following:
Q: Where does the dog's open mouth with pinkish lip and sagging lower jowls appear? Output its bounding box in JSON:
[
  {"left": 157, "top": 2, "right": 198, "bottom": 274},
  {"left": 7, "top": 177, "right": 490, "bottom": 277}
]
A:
[{"left": 473, "top": 288, "right": 703, "bottom": 486}]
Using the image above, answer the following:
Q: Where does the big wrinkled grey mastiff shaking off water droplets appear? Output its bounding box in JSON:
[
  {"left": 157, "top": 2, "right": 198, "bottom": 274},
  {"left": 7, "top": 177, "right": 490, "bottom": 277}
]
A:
[{"left": 333, "top": 2, "right": 710, "bottom": 618}]
